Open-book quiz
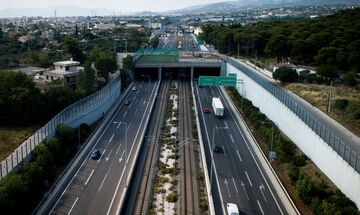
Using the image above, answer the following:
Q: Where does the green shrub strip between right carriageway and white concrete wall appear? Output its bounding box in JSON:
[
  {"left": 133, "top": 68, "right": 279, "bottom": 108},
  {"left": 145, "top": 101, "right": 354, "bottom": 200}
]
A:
[{"left": 226, "top": 87, "right": 359, "bottom": 215}]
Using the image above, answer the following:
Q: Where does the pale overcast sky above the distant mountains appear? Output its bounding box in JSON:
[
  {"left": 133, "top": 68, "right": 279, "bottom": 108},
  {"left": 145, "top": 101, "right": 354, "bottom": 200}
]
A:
[{"left": 0, "top": 0, "right": 226, "bottom": 13}]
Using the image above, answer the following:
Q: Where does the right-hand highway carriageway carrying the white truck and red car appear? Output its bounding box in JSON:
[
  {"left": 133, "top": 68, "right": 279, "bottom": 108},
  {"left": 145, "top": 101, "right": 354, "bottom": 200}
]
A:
[{"left": 194, "top": 81, "right": 287, "bottom": 214}]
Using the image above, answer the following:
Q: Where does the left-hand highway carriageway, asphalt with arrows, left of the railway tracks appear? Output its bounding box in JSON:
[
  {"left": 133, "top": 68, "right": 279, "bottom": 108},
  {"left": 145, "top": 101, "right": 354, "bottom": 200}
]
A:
[{"left": 44, "top": 80, "right": 158, "bottom": 214}]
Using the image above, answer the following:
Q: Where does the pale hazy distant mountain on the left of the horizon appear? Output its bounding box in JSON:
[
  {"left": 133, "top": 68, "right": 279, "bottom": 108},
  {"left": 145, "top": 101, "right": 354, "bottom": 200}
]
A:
[{"left": 0, "top": 6, "right": 113, "bottom": 17}]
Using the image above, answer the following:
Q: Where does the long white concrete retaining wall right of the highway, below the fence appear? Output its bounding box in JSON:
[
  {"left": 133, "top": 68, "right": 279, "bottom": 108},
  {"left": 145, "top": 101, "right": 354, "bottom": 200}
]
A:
[{"left": 227, "top": 63, "right": 360, "bottom": 208}]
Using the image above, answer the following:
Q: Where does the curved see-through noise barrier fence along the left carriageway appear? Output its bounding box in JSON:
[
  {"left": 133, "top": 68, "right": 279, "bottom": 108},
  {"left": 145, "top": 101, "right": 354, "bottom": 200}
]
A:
[{"left": 0, "top": 75, "right": 121, "bottom": 178}]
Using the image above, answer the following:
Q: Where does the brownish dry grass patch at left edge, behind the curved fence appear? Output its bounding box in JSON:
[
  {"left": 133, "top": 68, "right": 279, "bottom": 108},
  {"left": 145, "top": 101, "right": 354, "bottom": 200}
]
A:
[{"left": 0, "top": 125, "right": 40, "bottom": 161}]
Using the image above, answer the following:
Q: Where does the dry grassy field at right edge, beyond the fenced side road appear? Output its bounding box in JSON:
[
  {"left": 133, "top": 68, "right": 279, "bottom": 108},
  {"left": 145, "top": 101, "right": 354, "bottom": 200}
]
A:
[{"left": 286, "top": 83, "right": 360, "bottom": 137}]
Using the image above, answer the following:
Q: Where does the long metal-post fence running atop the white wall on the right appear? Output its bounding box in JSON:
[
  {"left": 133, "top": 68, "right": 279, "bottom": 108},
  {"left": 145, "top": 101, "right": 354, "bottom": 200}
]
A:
[{"left": 226, "top": 58, "right": 360, "bottom": 173}]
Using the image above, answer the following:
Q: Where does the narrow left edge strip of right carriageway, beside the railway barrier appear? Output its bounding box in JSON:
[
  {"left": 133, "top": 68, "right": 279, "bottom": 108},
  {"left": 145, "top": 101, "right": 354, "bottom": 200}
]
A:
[{"left": 194, "top": 82, "right": 225, "bottom": 214}]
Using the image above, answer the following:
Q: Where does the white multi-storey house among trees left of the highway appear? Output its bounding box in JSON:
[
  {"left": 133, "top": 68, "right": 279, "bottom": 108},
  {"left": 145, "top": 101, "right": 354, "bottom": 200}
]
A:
[{"left": 44, "top": 59, "right": 84, "bottom": 86}]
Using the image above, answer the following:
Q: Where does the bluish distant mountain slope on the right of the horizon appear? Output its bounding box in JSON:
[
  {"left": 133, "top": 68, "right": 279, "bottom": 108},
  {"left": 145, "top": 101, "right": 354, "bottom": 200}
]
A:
[{"left": 168, "top": 0, "right": 360, "bottom": 14}]
